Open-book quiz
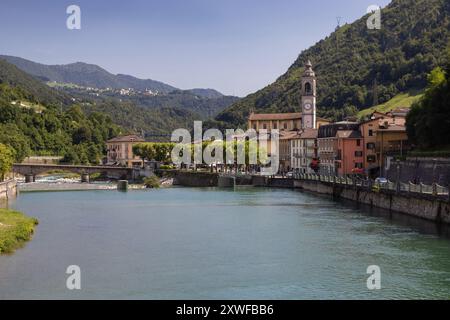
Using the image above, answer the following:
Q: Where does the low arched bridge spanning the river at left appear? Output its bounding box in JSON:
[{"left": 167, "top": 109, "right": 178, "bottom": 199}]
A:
[{"left": 13, "top": 163, "right": 139, "bottom": 183}]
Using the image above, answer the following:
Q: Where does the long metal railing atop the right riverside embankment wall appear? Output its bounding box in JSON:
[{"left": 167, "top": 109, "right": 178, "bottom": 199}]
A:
[{"left": 293, "top": 173, "right": 450, "bottom": 199}]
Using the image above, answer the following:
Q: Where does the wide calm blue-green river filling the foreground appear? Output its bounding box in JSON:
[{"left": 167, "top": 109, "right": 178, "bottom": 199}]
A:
[{"left": 0, "top": 187, "right": 450, "bottom": 299}]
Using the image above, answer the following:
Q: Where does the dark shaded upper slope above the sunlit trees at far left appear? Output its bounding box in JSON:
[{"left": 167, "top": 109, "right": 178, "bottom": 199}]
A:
[{"left": 0, "top": 58, "right": 72, "bottom": 106}]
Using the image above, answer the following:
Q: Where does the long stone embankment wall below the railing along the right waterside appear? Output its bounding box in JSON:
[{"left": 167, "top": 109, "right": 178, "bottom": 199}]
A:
[{"left": 294, "top": 180, "right": 450, "bottom": 224}]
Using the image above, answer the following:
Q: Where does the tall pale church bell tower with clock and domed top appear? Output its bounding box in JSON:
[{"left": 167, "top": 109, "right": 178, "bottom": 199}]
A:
[{"left": 301, "top": 60, "right": 317, "bottom": 129}]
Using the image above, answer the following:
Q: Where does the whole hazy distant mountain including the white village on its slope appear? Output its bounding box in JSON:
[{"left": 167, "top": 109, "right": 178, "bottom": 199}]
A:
[{"left": 0, "top": 55, "right": 239, "bottom": 120}]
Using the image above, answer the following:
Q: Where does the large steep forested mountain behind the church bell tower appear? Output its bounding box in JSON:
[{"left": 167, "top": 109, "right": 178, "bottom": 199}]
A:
[{"left": 216, "top": 0, "right": 450, "bottom": 126}]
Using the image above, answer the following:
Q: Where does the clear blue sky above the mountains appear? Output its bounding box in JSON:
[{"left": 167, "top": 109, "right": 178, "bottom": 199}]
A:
[{"left": 0, "top": 0, "right": 390, "bottom": 96}]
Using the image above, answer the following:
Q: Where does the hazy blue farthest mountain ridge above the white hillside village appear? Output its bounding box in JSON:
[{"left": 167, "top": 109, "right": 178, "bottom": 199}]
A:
[{"left": 0, "top": 55, "right": 177, "bottom": 93}]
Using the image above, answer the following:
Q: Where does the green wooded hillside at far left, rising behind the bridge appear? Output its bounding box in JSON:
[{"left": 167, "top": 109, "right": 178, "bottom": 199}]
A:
[{"left": 0, "top": 61, "right": 123, "bottom": 164}]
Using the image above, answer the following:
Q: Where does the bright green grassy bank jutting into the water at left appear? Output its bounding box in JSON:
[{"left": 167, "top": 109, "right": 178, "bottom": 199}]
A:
[{"left": 0, "top": 209, "right": 38, "bottom": 254}]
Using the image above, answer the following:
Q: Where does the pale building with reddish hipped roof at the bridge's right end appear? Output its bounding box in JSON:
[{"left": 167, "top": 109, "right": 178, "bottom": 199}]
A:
[{"left": 106, "top": 135, "right": 145, "bottom": 167}]
